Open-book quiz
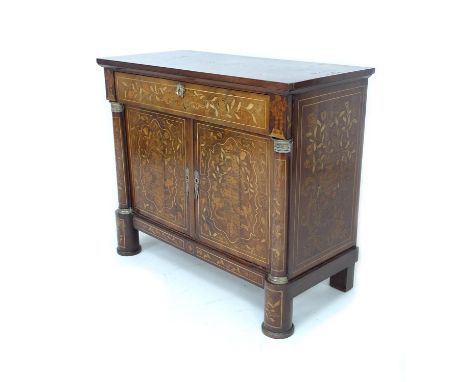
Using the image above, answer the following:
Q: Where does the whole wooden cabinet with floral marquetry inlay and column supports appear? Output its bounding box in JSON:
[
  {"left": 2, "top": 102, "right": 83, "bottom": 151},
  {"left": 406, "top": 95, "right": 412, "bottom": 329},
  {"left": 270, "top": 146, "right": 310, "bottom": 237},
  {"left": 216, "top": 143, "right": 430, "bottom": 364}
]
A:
[{"left": 97, "top": 51, "right": 374, "bottom": 338}]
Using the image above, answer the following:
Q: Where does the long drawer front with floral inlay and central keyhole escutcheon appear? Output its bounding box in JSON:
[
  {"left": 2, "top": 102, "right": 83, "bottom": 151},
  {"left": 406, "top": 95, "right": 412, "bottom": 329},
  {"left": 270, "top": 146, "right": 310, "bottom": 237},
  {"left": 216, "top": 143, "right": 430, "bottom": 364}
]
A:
[{"left": 115, "top": 72, "right": 269, "bottom": 134}]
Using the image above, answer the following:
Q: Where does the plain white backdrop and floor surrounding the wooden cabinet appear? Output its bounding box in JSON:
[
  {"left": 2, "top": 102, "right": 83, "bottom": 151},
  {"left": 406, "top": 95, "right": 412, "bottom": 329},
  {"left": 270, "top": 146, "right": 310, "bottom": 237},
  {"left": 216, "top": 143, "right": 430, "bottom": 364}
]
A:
[{"left": 0, "top": 0, "right": 468, "bottom": 382}]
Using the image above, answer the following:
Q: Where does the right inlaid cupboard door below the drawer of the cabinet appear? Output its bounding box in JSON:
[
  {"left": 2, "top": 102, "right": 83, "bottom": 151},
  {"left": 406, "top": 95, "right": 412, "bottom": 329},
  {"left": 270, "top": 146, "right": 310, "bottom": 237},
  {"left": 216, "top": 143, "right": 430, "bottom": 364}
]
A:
[{"left": 195, "top": 122, "right": 272, "bottom": 266}]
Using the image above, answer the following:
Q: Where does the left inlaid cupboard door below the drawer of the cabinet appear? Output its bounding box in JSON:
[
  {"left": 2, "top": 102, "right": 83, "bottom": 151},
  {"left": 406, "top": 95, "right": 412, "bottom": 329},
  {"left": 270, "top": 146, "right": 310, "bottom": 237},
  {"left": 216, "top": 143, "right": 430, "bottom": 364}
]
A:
[{"left": 125, "top": 107, "right": 193, "bottom": 234}]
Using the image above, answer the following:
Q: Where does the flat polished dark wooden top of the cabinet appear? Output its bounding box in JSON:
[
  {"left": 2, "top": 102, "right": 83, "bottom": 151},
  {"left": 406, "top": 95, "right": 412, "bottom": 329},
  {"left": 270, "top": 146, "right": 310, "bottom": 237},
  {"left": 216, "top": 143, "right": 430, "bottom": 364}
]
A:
[{"left": 97, "top": 50, "right": 374, "bottom": 90}]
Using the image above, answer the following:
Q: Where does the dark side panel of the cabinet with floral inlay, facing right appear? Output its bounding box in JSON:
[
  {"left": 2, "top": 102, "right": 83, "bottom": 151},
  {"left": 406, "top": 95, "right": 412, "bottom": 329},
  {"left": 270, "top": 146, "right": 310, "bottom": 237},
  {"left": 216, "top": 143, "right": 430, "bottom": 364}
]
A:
[{"left": 290, "top": 81, "right": 367, "bottom": 277}]
